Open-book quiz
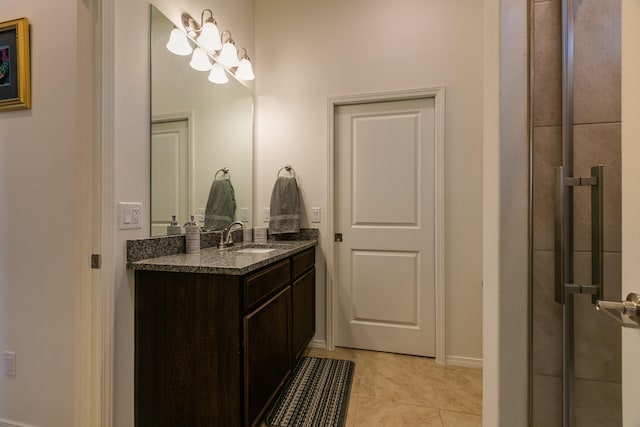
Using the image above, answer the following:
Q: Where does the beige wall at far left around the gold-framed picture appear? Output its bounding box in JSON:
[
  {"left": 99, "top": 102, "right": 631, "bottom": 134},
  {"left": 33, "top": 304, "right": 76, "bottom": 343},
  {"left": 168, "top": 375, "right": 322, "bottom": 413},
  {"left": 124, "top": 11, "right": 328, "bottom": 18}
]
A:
[{"left": 0, "top": 0, "right": 92, "bottom": 427}]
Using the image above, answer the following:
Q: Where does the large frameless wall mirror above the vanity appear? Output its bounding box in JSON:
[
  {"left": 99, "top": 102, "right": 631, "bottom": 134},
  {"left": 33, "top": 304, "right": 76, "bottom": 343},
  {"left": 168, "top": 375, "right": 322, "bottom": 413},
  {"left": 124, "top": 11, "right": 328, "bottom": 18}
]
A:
[{"left": 150, "top": 5, "right": 253, "bottom": 236}]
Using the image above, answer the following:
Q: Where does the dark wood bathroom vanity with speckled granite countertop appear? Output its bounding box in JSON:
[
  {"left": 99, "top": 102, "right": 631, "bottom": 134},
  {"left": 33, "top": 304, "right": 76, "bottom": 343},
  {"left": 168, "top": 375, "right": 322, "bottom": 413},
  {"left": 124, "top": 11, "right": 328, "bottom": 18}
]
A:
[{"left": 129, "top": 241, "right": 316, "bottom": 427}]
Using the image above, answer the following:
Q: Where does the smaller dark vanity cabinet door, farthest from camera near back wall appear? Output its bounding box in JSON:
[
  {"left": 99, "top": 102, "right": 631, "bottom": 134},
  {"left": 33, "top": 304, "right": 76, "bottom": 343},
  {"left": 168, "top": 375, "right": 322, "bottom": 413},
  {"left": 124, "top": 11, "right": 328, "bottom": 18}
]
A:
[{"left": 291, "top": 268, "right": 316, "bottom": 359}]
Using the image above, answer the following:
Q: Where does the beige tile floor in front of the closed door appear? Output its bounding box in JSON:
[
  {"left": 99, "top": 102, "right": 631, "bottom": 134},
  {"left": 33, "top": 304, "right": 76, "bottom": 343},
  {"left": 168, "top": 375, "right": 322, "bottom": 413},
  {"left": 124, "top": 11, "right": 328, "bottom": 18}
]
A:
[{"left": 307, "top": 348, "right": 482, "bottom": 427}]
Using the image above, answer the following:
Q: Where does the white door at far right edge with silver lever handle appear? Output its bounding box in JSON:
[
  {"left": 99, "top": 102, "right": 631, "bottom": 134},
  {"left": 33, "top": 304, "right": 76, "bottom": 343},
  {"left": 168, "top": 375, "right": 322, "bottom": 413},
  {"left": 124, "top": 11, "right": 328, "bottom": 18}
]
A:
[{"left": 622, "top": 0, "right": 640, "bottom": 427}]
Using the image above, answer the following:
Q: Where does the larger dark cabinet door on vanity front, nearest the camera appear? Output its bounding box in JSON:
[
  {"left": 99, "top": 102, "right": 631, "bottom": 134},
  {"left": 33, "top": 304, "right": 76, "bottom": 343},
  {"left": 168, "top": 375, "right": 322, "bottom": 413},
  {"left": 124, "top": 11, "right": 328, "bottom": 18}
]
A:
[{"left": 244, "top": 286, "right": 291, "bottom": 426}]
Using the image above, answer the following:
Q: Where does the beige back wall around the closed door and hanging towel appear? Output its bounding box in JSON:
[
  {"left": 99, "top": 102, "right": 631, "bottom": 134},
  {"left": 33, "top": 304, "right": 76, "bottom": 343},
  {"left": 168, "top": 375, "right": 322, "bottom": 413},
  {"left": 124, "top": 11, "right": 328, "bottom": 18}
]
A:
[{"left": 254, "top": 0, "right": 483, "bottom": 361}]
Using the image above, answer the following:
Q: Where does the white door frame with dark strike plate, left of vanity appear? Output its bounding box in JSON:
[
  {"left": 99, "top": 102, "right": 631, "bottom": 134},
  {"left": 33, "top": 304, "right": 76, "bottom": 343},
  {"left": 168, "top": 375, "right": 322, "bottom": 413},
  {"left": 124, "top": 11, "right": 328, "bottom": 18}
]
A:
[{"left": 79, "top": 0, "right": 116, "bottom": 427}]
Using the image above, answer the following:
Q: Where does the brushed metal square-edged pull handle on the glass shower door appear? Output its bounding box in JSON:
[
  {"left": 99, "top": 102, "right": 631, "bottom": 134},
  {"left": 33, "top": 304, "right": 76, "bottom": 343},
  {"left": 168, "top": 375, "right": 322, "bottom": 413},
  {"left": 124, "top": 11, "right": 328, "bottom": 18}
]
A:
[{"left": 554, "top": 165, "right": 604, "bottom": 304}]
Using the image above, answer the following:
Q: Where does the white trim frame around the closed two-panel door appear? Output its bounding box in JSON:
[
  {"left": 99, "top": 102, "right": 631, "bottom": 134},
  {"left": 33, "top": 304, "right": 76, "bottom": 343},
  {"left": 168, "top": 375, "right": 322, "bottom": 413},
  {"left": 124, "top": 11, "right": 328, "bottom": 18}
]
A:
[{"left": 320, "top": 86, "right": 446, "bottom": 364}]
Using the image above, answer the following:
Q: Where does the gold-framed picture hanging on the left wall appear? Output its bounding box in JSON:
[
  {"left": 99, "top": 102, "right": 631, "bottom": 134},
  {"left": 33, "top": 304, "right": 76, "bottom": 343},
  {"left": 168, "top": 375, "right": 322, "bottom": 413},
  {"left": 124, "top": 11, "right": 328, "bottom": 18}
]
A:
[{"left": 0, "top": 18, "right": 31, "bottom": 111}]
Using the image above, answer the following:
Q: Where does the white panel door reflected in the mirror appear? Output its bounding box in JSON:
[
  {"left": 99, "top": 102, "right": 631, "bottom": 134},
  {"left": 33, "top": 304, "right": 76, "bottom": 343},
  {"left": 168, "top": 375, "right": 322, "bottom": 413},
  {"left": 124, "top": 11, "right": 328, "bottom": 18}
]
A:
[{"left": 151, "top": 120, "right": 189, "bottom": 236}]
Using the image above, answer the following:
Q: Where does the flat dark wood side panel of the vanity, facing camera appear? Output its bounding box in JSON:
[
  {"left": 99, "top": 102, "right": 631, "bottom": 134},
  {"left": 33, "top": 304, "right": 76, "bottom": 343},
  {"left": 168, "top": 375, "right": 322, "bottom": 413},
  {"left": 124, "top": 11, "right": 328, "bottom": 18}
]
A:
[{"left": 135, "top": 271, "right": 242, "bottom": 427}]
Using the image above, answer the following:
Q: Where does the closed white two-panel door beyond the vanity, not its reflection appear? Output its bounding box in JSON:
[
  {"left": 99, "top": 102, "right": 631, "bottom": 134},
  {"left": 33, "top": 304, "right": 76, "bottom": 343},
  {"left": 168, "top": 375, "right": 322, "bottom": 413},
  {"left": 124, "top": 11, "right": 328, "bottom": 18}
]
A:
[{"left": 335, "top": 98, "right": 435, "bottom": 356}]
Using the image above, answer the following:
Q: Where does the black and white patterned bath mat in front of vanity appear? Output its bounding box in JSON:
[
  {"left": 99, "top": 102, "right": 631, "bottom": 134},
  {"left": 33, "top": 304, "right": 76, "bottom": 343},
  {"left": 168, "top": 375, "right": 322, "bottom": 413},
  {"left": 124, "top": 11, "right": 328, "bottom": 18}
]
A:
[{"left": 265, "top": 357, "right": 355, "bottom": 427}]
